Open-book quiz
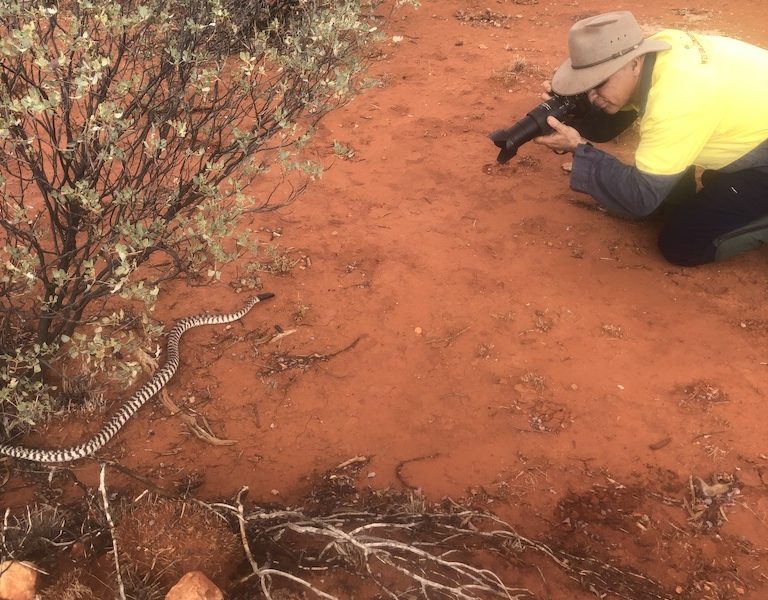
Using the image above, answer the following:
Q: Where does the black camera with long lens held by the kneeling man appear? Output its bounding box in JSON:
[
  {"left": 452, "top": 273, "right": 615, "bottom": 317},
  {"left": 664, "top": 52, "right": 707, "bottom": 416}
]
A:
[{"left": 488, "top": 93, "right": 592, "bottom": 164}]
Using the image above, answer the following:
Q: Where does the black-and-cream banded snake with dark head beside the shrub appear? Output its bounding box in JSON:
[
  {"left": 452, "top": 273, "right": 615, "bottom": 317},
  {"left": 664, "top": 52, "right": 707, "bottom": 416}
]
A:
[{"left": 0, "top": 292, "right": 274, "bottom": 463}]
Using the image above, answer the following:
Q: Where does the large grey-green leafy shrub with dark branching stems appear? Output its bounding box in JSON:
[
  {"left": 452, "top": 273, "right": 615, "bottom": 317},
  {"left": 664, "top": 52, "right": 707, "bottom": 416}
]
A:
[{"left": 0, "top": 0, "right": 408, "bottom": 433}]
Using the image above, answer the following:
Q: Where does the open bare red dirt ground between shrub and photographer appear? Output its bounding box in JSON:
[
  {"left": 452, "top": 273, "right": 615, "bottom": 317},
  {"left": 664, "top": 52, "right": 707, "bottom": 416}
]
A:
[{"left": 4, "top": 0, "right": 768, "bottom": 599}]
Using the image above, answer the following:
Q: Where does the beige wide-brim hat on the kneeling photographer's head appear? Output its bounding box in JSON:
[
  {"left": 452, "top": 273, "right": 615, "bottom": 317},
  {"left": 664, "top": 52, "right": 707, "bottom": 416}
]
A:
[{"left": 552, "top": 10, "right": 670, "bottom": 96}]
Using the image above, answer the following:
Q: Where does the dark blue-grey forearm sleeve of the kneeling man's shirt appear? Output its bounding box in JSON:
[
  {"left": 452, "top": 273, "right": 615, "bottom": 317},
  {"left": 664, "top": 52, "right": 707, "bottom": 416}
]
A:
[{"left": 571, "top": 144, "right": 685, "bottom": 218}]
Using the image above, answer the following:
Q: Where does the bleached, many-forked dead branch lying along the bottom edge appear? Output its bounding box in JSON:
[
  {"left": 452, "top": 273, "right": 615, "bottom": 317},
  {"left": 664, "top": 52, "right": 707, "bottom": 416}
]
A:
[{"left": 200, "top": 488, "right": 672, "bottom": 600}]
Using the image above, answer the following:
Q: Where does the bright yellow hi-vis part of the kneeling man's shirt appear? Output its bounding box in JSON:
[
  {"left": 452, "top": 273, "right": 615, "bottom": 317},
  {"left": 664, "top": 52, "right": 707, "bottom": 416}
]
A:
[{"left": 635, "top": 29, "right": 768, "bottom": 175}]
